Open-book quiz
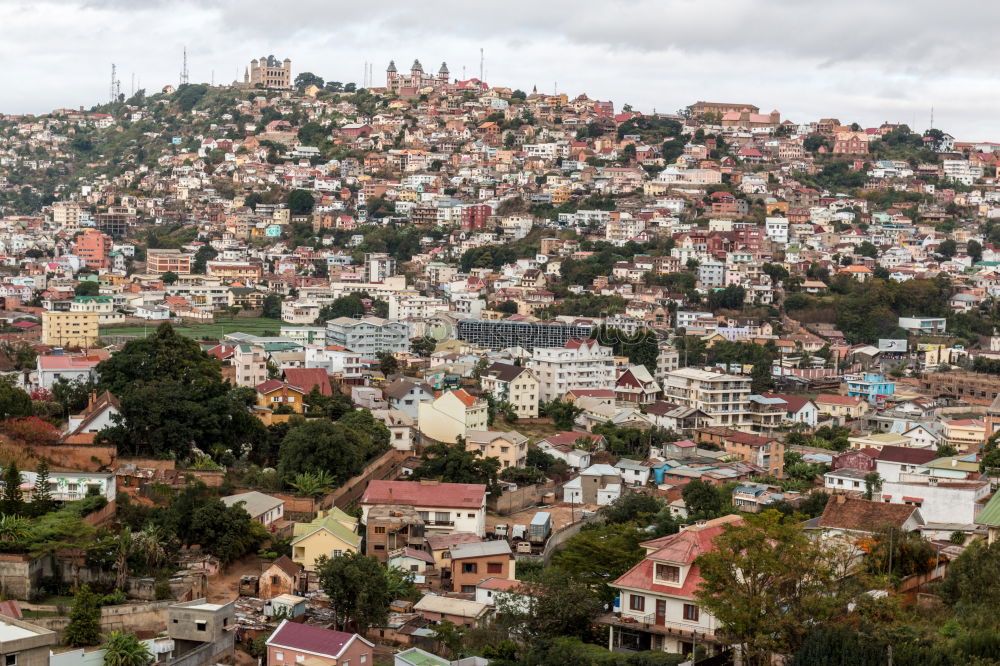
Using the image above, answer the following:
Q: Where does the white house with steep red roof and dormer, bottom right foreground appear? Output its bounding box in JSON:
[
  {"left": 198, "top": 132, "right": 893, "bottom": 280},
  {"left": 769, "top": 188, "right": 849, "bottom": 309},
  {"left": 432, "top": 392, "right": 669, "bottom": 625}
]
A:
[{"left": 598, "top": 515, "right": 742, "bottom": 654}]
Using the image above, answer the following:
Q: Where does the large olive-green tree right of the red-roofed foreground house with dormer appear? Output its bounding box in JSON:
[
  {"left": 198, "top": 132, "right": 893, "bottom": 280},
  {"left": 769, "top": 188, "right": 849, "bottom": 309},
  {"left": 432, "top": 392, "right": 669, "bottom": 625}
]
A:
[{"left": 695, "top": 511, "right": 844, "bottom": 666}]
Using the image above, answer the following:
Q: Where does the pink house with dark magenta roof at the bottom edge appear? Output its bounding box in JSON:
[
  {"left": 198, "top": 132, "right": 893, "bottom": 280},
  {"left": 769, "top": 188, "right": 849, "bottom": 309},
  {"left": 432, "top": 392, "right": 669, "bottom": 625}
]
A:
[{"left": 267, "top": 620, "right": 374, "bottom": 666}]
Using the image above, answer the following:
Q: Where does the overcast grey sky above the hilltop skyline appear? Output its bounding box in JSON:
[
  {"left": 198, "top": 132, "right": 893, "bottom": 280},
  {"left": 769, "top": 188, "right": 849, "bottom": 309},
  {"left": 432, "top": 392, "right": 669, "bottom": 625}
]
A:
[{"left": 0, "top": 0, "right": 1000, "bottom": 140}]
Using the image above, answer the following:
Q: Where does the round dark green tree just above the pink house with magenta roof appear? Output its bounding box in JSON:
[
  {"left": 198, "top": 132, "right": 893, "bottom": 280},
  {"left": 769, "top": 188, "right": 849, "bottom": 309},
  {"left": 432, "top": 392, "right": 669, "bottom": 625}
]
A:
[{"left": 316, "top": 551, "right": 392, "bottom": 634}]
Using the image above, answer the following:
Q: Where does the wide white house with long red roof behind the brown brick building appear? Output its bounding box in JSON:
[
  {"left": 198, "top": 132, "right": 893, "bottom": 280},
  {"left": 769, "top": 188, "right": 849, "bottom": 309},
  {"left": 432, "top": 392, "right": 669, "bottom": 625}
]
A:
[{"left": 359, "top": 479, "right": 486, "bottom": 537}]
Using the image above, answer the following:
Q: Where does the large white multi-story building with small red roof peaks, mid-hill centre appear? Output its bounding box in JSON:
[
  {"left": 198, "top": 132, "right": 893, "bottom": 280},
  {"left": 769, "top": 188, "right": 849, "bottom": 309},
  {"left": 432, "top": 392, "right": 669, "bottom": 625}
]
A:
[{"left": 528, "top": 338, "right": 615, "bottom": 402}]
